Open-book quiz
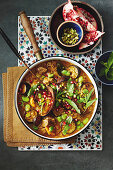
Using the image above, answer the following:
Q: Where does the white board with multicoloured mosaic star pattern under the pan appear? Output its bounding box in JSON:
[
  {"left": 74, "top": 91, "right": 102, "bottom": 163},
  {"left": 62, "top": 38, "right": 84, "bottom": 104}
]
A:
[{"left": 18, "top": 16, "right": 102, "bottom": 151}]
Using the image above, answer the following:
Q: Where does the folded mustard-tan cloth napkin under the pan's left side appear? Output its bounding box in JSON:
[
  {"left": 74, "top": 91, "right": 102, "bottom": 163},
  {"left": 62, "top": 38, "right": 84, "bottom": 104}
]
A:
[{"left": 2, "top": 67, "right": 75, "bottom": 147}]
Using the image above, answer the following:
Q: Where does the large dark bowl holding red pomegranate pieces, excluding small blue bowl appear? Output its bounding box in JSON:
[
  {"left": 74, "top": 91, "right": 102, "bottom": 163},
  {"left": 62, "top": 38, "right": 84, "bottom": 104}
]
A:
[{"left": 49, "top": 0, "right": 104, "bottom": 54}]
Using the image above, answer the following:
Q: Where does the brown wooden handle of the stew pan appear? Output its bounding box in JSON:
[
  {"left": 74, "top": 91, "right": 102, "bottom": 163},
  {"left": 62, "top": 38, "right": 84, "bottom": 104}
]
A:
[{"left": 19, "top": 11, "right": 44, "bottom": 60}]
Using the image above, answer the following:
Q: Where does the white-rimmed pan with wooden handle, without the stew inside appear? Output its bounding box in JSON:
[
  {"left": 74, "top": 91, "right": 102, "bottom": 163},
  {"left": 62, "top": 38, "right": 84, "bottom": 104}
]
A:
[{"left": 15, "top": 12, "right": 98, "bottom": 140}]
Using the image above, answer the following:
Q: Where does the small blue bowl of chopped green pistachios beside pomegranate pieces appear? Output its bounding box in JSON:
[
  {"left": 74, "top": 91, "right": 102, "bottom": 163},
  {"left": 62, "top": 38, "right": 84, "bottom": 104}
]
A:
[{"left": 57, "top": 21, "right": 83, "bottom": 47}]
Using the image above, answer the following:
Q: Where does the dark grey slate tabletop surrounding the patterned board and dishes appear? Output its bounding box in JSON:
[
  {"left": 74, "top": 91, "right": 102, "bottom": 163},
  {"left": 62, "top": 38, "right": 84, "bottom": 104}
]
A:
[{"left": 0, "top": 0, "right": 113, "bottom": 170}]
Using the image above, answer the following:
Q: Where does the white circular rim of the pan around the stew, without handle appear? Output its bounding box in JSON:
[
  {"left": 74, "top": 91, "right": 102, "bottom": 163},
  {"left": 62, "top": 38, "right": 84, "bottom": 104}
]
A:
[{"left": 15, "top": 57, "right": 98, "bottom": 141}]
